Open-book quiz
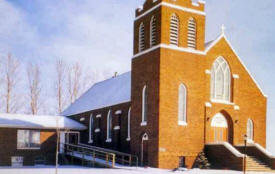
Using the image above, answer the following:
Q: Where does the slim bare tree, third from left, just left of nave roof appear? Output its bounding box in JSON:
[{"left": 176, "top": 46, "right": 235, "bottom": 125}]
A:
[{"left": 54, "top": 59, "right": 66, "bottom": 115}]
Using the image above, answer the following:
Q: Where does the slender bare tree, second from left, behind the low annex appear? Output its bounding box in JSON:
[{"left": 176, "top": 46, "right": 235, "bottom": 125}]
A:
[{"left": 27, "top": 63, "right": 43, "bottom": 115}]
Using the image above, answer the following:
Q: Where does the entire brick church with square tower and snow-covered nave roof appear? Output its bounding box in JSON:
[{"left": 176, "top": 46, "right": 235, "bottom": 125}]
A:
[{"left": 63, "top": 0, "right": 272, "bottom": 168}]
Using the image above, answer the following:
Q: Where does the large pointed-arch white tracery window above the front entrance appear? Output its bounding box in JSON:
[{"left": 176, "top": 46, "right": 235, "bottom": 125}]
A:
[{"left": 210, "top": 56, "right": 232, "bottom": 104}]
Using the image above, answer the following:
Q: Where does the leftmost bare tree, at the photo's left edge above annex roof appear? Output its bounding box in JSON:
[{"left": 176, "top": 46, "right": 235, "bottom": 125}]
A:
[{"left": 2, "top": 54, "right": 23, "bottom": 113}]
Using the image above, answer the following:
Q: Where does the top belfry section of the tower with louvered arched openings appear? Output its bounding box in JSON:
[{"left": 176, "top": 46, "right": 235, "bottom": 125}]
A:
[{"left": 134, "top": 0, "right": 205, "bottom": 55}]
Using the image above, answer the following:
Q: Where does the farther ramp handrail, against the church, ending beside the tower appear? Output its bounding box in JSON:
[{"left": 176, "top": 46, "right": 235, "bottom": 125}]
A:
[{"left": 78, "top": 143, "right": 138, "bottom": 166}]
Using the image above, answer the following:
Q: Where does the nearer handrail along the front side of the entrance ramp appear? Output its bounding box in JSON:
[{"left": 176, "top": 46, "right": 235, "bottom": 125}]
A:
[{"left": 61, "top": 143, "right": 116, "bottom": 167}]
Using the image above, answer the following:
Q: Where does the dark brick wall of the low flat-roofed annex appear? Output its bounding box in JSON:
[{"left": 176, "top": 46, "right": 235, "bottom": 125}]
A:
[{"left": 0, "top": 128, "right": 56, "bottom": 166}]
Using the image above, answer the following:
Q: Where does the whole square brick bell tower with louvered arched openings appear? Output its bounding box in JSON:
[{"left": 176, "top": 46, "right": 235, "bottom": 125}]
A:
[{"left": 130, "top": 0, "right": 205, "bottom": 168}]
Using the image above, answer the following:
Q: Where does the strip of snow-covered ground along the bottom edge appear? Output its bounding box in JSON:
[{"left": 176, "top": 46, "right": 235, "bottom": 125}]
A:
[{"left": 0, "top": 166, "right": 271, "bottom": 174}]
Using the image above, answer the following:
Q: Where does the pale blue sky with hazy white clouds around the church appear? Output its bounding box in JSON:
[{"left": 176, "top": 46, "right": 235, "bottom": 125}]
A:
[{"left": 0, "top": 0, "right": 275, "bottom": 154}]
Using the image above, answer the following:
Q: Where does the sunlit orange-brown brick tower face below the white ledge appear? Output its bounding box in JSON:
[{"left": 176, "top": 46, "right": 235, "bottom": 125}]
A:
[{"left": 159, "top": 49, "right": 205, "bottom": 168}]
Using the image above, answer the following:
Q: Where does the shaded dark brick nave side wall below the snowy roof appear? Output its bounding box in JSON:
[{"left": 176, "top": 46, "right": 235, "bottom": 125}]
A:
[{"left": 69, "top": 102, "right": 133, "bottom": 153}]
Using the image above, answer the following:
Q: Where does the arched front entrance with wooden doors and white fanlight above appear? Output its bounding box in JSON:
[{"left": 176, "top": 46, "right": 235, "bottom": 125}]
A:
[{"left": 211, "top": 113, "right": 231, "bottom": 142}]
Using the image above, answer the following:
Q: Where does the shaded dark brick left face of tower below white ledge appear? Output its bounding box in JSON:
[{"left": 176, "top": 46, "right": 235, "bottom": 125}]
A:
[{"left": 131, "top": 49, "right": 160, "bottom": 167}]
